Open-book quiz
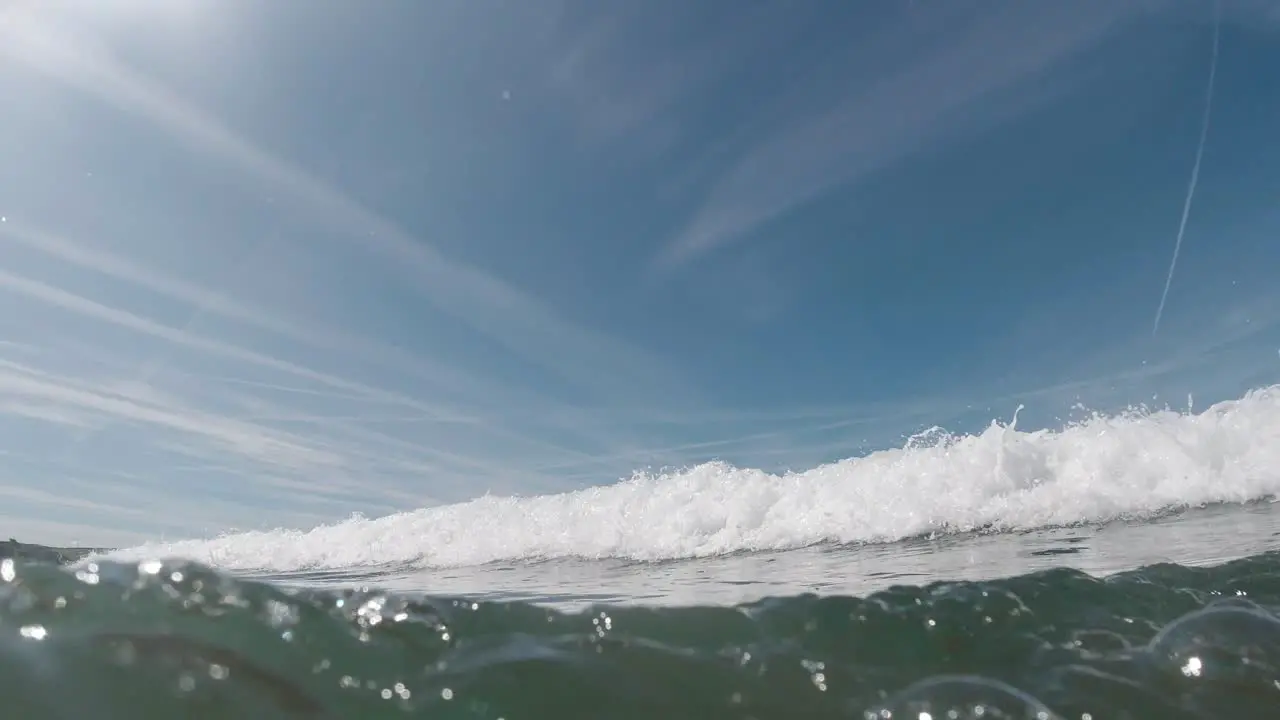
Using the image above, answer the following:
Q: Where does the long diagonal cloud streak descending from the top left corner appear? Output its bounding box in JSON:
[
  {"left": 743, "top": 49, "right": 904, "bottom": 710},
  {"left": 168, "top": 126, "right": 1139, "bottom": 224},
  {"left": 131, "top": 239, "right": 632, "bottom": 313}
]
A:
[{"left": 0, "top": 15, "right": 689, "bottom": 398}]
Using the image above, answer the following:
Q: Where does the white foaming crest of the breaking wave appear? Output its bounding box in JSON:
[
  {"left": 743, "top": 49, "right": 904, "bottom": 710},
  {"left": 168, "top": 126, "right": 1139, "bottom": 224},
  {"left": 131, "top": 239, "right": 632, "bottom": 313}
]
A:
[{"left": 111, "top": 386, "right": 1280, "bottom": 571}]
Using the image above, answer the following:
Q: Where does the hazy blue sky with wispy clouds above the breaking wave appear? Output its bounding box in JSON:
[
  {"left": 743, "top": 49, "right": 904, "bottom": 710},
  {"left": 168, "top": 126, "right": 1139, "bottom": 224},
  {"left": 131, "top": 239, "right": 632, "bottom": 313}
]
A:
[{"left": 0, "top": 0, "right": 1280, "bottom": 543}]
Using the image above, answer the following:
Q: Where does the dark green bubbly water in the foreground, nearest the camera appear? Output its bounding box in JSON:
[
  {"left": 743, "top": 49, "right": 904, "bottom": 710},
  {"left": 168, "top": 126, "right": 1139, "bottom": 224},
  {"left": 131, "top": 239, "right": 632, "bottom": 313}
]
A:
[{"left": 0, "top": 552, "right": 1280, "bottom": 720}]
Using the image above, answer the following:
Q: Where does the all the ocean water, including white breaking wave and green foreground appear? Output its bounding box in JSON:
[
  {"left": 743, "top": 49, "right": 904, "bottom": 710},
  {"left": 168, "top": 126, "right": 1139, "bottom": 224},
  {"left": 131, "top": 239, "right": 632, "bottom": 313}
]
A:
[{"left": 0, "top": 386, "right": 1280, "bottom": 720}]
